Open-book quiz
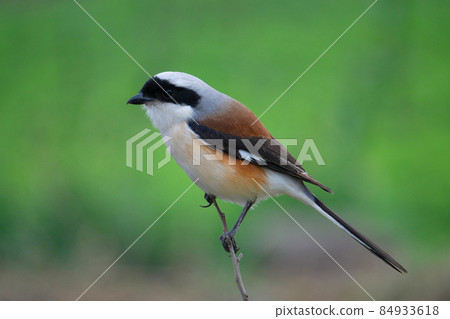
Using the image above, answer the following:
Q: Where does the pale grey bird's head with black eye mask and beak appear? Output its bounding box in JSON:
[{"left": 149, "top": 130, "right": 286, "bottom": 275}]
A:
[{"left": 127, "top": 72, "right": 231, "bottom": 130}]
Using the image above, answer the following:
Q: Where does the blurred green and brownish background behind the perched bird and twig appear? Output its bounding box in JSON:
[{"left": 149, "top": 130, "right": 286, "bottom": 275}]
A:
[{"left": 0, "top": 0, "right": 450, "bottom": 300}]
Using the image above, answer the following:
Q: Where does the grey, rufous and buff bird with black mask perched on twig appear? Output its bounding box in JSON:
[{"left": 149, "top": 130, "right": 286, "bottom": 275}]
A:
[{"left": 127, "top": 71, "right": 407, "bottom": 273}]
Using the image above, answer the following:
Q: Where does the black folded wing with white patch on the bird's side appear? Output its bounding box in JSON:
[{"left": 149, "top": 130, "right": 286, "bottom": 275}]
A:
[{"left": 188, "top": 121, "right": 332, "bottom": 193}]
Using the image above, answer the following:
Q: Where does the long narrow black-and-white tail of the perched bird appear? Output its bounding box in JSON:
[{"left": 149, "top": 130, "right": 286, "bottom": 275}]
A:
[{"left": 309, "top": 192, "right": 408, "bottom": 273}]
